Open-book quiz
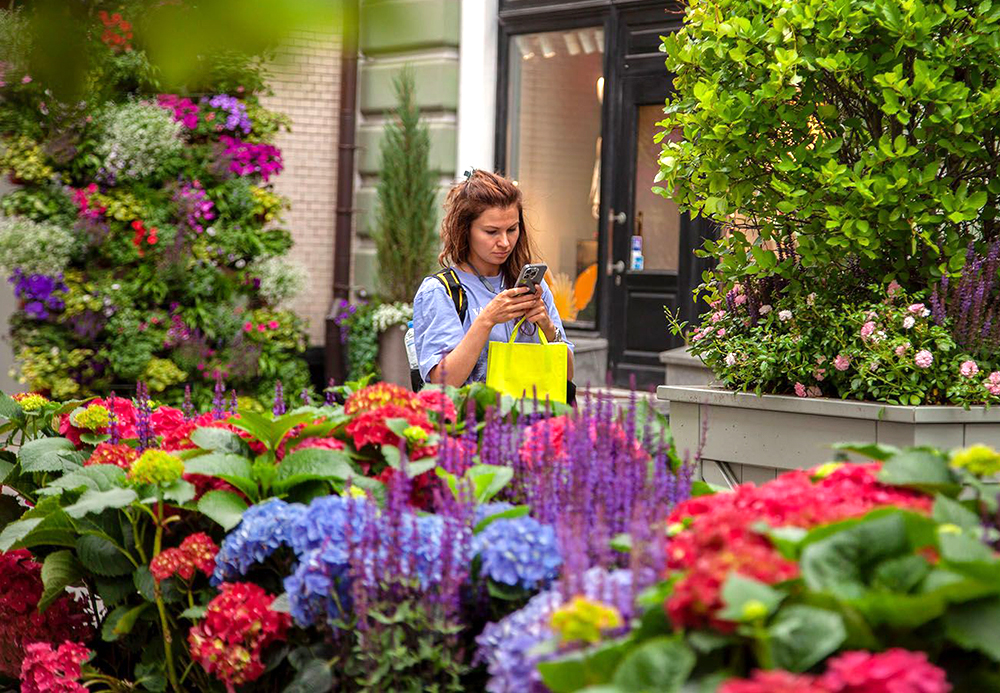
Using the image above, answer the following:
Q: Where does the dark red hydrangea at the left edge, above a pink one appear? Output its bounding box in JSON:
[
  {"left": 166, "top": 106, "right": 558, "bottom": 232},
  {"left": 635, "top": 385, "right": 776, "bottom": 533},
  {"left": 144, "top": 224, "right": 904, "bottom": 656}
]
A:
[{"left": 0, "top": 549, "right": 92, "bottom": 678}]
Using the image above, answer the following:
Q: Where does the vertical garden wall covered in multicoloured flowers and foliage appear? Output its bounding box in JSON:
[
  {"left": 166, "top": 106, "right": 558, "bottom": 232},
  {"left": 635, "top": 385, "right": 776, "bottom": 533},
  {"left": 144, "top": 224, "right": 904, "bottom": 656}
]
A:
[{"left": 0, "top": 6, "right": 310, "bottom": 407}]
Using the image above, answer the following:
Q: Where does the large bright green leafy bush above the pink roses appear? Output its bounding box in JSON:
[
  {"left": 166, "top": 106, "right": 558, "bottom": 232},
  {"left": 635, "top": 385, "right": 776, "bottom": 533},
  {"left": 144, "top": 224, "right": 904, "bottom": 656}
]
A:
[{"left": 658, "top": 0, "right": 1000, "bottom": 291}]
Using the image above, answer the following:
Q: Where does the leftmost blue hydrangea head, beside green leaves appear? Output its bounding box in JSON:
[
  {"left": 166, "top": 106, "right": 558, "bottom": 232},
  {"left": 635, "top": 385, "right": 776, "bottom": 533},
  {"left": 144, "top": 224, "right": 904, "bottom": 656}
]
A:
[{"left": 212, "top": 498, "right": 306, "bottom": 585}]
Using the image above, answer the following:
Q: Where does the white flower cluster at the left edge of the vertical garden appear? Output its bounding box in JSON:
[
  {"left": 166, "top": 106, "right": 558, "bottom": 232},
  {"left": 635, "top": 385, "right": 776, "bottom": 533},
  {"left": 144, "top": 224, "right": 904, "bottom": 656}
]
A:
[{"left": 0, "top": 217, "right": 77, "bottom": 275}]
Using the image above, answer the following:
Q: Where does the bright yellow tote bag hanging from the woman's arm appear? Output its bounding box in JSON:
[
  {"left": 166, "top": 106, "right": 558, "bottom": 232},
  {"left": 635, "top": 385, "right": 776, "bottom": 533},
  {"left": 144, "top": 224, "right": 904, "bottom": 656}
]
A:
[{"left": 486, "top": 318, "right": 569, "bottom": 403}]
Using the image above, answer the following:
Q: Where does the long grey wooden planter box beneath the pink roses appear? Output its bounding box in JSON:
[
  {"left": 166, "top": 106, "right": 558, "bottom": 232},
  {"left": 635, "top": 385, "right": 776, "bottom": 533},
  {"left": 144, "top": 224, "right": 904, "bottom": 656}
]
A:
[{"left": 656, "top": 385, "right": 1000, "bottom": 486}]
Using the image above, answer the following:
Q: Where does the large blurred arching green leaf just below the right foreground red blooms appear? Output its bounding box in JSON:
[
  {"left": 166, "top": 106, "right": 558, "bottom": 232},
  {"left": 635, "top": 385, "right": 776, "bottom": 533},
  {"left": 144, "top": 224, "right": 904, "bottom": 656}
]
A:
[{"left": 801, "top": 513, "right": 910, "bottom": 599}]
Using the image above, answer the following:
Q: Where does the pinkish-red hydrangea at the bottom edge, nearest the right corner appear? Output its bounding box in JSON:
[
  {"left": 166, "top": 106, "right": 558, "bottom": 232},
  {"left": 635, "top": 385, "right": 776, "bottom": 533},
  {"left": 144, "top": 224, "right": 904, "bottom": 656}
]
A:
[{"left": 820, "top": 647, "right": 951, "bottom": 693}]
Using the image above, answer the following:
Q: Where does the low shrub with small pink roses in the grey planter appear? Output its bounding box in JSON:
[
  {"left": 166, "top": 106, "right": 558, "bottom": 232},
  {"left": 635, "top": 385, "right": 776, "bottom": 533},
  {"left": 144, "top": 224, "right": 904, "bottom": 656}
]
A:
[{"left": 691, "top": 286, "right": 1000, "bottom": 405}]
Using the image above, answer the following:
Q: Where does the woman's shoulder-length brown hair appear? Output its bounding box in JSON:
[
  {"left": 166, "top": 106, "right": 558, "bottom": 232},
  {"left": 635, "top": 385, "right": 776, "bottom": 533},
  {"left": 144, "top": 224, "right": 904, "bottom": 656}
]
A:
[{"left": 438, "top": 169, "right": 533, "bottom": 287}]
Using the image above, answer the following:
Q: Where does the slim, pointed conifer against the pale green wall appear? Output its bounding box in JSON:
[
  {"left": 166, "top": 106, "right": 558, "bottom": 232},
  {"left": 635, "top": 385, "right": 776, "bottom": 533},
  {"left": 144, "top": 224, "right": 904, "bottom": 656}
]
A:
[{"left": 373, "top": 68, "right": 438, "bottom": 303}]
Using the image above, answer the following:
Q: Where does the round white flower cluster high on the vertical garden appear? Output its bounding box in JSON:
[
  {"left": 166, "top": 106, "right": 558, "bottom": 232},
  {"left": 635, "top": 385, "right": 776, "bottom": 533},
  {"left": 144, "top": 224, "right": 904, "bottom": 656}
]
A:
[{"left": 96, "top": 101, "right": 183, "bottom": 180}]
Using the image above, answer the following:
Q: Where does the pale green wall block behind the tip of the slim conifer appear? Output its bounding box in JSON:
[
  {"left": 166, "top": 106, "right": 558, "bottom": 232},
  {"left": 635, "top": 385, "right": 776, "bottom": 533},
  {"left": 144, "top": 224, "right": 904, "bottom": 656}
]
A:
[{"left": 359, "top": 59, "right": 458, "bottom": 113}]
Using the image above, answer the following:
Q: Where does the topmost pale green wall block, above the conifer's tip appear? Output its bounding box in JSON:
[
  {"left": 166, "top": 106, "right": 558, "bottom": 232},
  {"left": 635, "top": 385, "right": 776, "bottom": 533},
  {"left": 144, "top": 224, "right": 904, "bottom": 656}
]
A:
[{"left": 360, "top": 0, "right": 460, "bottom": 55}]
